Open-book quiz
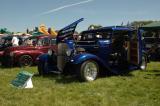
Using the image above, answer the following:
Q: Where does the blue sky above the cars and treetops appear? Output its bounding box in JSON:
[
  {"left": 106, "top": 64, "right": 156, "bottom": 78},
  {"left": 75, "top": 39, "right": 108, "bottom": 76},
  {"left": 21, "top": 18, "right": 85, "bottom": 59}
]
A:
[{"left": 0, "top": 0, "right": 160, "bottom": 32}]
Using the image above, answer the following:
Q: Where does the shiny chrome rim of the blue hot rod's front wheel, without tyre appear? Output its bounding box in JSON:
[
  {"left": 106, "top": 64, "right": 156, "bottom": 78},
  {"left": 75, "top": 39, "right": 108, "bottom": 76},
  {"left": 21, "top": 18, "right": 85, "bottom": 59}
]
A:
[{"left": 84, "top": 62, "right": 98, "bottom": 81}]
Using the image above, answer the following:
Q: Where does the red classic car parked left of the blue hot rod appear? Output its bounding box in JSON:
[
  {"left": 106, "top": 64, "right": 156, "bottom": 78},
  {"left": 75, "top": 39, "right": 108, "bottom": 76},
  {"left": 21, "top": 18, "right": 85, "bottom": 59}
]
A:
[{"left": 1, "top": 35, "right": 57, "bottom": 66}]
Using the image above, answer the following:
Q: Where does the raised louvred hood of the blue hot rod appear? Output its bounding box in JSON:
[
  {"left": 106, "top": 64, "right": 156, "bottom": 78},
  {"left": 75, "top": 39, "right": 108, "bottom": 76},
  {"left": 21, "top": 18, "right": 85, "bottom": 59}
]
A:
[{"left": 57, "top": 18, "right": 84, "bottom": 43}]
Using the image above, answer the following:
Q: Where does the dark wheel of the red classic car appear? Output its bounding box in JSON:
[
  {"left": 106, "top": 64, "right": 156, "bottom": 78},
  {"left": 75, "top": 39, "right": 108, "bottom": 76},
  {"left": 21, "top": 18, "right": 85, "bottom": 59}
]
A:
[{"left": 19, "top": 55, "right": 33, "bottom": 67}]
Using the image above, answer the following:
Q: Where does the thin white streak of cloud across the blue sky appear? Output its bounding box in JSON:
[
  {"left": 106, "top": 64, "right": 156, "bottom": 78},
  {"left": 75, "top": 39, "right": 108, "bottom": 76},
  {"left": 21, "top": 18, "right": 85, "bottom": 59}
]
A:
[{"left": 39, "top": 0, "right": 94, "bottom": 16}]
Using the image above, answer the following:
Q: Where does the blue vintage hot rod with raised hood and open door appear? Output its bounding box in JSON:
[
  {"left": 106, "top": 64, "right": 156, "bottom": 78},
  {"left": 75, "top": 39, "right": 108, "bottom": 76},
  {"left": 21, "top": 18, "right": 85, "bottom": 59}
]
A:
[{"left": 38, "top": 18, "right": 147, "bottom": 81}]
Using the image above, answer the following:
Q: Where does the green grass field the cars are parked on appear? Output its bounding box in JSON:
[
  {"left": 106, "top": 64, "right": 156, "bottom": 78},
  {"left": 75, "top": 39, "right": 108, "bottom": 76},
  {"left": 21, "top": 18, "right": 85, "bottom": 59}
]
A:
[{"left": 0, "top": 62, "right": 160, "bottom": 106}]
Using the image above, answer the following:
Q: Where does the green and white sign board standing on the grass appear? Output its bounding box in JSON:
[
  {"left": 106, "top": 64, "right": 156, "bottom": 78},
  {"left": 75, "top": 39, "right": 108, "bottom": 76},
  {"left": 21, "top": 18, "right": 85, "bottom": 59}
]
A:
[{"left": 11, "top": 71, "right": 33, "bottom": 88}]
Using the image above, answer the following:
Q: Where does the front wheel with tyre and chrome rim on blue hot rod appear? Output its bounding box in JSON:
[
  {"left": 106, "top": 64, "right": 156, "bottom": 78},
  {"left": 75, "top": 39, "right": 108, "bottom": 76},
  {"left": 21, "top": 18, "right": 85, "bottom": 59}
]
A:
[{"left": 78, "top": 60, "right": 99, "bottom": 82}]
